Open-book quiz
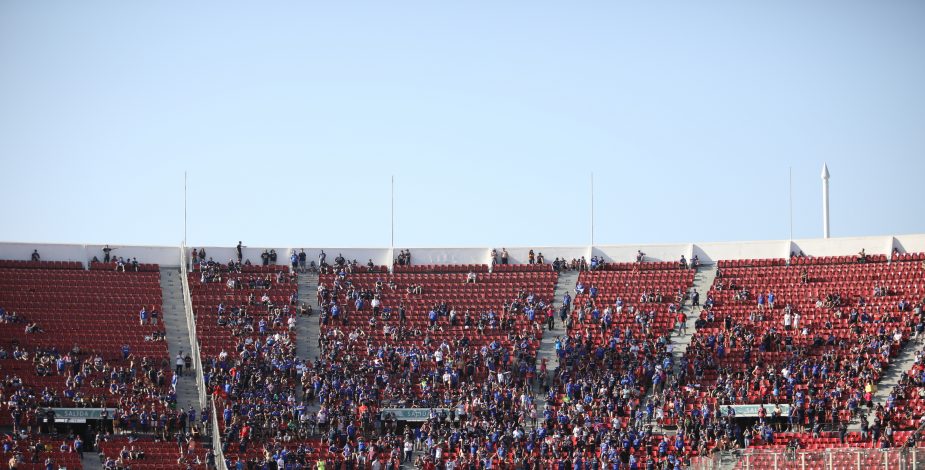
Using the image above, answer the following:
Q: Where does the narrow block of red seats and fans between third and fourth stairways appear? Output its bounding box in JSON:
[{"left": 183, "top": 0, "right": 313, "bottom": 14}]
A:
[{"left": 537, "top": 259, "right": 693, "bottom": 468}]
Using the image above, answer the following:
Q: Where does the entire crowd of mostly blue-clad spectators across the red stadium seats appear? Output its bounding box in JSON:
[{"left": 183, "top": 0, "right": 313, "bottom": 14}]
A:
[{"left": 10, "top": 245, "right": 925, "bottom": 469}]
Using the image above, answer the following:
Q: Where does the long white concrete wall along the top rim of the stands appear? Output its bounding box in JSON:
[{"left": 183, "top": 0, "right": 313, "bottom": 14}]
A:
[{"left": 0, "top": 234, "right": 925, "bottom": 266}]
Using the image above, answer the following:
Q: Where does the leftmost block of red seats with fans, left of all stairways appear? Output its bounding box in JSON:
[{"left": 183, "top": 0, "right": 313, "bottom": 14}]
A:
[{"left": 0, "top": 256, "right": 211, "bottom": 469}]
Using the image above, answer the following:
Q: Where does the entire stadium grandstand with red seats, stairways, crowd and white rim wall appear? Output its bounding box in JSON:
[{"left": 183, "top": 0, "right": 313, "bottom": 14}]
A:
[{"left": 0, "top": 235, "right": 925, "bottom": 470}]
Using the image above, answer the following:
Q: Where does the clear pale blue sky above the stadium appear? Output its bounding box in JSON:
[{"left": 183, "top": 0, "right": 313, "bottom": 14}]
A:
[{"left": 0, "top": 0, "right": 925, "bottom": 246}]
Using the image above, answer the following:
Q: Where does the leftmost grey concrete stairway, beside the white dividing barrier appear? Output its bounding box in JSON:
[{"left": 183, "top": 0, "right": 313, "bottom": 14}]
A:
[{"left": 161, "top": 268, "right": 201, "bottom": 414}]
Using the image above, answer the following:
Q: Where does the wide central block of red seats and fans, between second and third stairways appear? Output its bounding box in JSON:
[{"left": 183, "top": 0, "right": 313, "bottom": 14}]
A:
[{"left": 308, "top": 258, "right": 556, "bottom": 466}]
